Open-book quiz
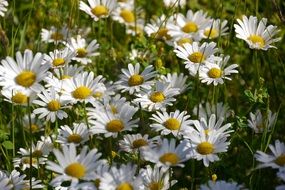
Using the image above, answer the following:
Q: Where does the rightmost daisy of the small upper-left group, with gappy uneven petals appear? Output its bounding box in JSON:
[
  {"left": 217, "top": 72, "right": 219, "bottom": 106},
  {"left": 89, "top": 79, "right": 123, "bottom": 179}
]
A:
[{"left": 65, "top": 35, "right": 99, "bottom": 65}]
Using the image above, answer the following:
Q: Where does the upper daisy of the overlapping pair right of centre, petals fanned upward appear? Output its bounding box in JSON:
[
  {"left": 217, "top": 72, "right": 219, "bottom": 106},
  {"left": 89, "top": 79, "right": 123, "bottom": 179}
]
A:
[{"left": 174, "top": 42, "right": 217, "bottom": 76}]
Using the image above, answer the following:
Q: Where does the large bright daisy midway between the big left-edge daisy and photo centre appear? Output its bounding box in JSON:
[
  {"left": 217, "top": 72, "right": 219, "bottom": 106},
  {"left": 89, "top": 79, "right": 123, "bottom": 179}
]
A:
[{"left": 62, "top": 72, "right": 106, "bottom": 106}]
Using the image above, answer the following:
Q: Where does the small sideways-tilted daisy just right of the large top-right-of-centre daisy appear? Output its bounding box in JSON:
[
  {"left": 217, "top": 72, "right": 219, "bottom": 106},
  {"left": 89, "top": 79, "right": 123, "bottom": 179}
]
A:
[{"left": 201, "top": 19, "right": 229, "bottom": 40}]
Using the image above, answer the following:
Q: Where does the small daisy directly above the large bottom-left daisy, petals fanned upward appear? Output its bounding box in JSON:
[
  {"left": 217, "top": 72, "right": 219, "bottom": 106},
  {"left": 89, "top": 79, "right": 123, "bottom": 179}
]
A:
[{"left": 56, "top": 123, "right": 89, "bottom": 145}]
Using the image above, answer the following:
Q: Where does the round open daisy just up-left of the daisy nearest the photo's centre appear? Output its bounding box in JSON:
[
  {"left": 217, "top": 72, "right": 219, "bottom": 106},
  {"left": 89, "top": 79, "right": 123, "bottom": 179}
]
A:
[{"left": 115, "top": 63, "right": 156, "bottom": 94}]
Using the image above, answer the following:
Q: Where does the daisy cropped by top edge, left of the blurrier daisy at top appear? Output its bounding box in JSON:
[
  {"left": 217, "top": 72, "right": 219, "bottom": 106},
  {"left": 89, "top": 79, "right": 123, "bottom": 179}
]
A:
[{"left": 79, "top": 0, "right": 117, "bottom": 21}]
